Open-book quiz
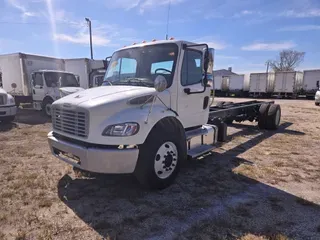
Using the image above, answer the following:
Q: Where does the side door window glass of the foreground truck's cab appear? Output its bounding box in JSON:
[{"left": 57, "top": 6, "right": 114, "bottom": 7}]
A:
[{"left": 181, "top": 50, "right": 202, "bottom": 86}]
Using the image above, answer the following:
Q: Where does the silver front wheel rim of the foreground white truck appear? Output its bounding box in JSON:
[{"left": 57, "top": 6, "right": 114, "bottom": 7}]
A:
[{"left": 154, "top": 142, "right": 178, "bottom": 179}]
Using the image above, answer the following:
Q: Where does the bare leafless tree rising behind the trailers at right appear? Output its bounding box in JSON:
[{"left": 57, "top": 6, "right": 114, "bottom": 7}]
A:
[{"left": 267, "top": 50, "right": 305, "bottom": 72}]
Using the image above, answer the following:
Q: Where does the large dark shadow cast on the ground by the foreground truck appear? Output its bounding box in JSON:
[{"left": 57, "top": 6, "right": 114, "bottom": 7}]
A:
[{"left": 58, "top": 123, "right": 320, "bottom": 239}]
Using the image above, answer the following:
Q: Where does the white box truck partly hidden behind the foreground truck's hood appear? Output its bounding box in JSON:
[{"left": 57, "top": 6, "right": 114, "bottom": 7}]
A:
[{"left": 65, "top": 58, "right": 107, "bottom": 89}]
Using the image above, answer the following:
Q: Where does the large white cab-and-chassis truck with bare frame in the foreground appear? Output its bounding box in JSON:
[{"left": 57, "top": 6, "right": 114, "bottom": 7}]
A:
[{"left": 48, "top": 40, "right": 281, "bottom": 189}]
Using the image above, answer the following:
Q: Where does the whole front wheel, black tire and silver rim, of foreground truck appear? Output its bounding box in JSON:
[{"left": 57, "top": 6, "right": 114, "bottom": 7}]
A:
[{"left": 134, "top": 118, "right": 187, "bottom": 189}]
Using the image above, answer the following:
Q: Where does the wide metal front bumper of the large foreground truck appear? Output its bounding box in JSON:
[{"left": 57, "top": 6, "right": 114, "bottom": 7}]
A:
[{"left": 48, "top": 132, "right": 139, "bottom": 173}]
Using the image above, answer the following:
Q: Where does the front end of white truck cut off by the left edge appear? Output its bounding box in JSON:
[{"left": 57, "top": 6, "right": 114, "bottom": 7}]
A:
[{"left": 0, "top": 87, "right": 17, "bottom": 123}]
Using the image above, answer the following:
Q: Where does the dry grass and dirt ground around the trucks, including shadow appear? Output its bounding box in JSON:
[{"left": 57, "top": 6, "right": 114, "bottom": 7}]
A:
[{"left": 0, "top": 99, "right": 320, "bottom": 240}]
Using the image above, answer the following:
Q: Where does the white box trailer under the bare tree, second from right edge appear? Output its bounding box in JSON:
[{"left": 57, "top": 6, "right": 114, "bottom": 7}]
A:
[{"left": 274, "top": 71, "right": 303, "bottom": 96}]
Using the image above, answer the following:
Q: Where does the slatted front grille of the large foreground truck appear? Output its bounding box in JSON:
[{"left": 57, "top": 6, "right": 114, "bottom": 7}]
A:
[{"left": 52, "top": 106, "right": 89, "bottom": 138}]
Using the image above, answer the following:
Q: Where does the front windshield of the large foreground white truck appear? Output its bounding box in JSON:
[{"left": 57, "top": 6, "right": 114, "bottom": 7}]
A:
[{"left": 102, "top": 43, "right": 178, "bottom": 87}]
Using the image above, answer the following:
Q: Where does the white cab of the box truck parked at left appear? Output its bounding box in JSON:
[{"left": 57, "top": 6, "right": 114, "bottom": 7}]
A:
[{"left": 31, "top": 70, "right": 83, "bottom": 116}]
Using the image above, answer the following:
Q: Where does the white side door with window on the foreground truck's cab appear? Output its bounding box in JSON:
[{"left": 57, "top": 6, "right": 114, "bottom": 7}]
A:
[{"left": 178, "top": 47, "right": 211, "bottom": 128}]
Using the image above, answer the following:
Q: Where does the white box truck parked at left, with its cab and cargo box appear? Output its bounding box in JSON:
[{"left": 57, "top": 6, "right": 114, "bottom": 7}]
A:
[{"left": 0, "top": 53, "right": 83, "bottom": 116}]
